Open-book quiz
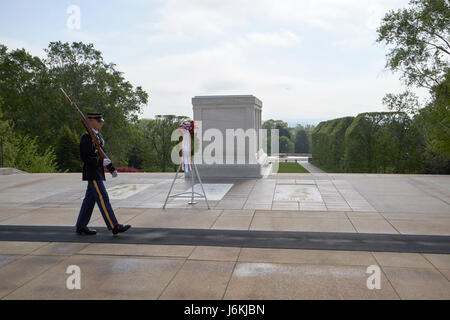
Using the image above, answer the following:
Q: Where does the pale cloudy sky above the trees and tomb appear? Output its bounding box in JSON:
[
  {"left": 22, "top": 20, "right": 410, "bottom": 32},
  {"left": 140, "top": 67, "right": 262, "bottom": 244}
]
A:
[{"left": 0, "top": 0, "right": 428, "bottom": 124}]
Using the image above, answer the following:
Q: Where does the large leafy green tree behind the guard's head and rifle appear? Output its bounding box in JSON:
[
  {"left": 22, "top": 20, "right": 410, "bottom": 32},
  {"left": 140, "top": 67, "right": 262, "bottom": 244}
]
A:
[{"left": 0, "top": 41, "right": 148, "bottom": 166}]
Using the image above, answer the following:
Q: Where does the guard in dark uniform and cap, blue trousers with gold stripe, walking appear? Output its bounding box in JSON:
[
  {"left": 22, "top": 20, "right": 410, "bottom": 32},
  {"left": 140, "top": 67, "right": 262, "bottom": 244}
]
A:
[{"left": 76, "top": 112, "right": 131, "bottom": 235}]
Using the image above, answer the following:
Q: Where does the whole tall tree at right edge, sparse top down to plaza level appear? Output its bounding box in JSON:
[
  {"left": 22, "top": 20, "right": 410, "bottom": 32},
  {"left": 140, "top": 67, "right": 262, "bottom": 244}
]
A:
[{"left": 377, "top": 0, "right": 450, "bottom": 173}]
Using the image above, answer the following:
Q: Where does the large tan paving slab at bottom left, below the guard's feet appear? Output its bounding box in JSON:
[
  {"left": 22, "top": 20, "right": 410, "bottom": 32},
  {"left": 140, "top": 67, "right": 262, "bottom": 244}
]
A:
[{"left": 0, "top": 255, "right": 184, "bottom": 300}]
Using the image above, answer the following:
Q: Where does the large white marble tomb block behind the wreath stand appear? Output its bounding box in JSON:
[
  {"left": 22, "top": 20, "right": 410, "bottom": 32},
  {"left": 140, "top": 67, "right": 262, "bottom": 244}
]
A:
[{"left": 186, "top": 95, "right": 267, "bottom": 179}]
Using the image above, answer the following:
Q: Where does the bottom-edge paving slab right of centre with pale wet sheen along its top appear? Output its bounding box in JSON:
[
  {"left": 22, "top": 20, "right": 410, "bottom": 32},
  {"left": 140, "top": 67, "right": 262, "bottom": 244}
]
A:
[{"left": 224, "top": 262, "right": 398, "bottom": 300}]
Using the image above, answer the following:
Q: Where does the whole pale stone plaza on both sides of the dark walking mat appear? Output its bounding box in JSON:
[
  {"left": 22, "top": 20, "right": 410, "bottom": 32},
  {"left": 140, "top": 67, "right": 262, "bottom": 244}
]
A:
[{"left": 0, "top": 172, "right": 450, "bottom": 299}]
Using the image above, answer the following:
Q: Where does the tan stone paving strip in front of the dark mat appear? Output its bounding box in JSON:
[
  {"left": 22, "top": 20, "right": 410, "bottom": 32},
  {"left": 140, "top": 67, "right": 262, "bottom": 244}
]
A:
[{"left": 0, "top": 242, "right": 450, "bottom": 299}]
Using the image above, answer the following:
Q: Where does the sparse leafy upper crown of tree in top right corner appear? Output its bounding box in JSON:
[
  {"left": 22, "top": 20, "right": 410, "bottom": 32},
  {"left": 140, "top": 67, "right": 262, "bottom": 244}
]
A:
[{"left": 377, "top": 0, "right": 450, "bottom": 89}]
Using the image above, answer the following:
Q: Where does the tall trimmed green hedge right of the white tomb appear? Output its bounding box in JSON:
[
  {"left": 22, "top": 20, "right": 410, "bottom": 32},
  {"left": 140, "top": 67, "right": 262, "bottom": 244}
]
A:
[{"left": 312, "top": 112, "right": 450, "bottom": 173}]
